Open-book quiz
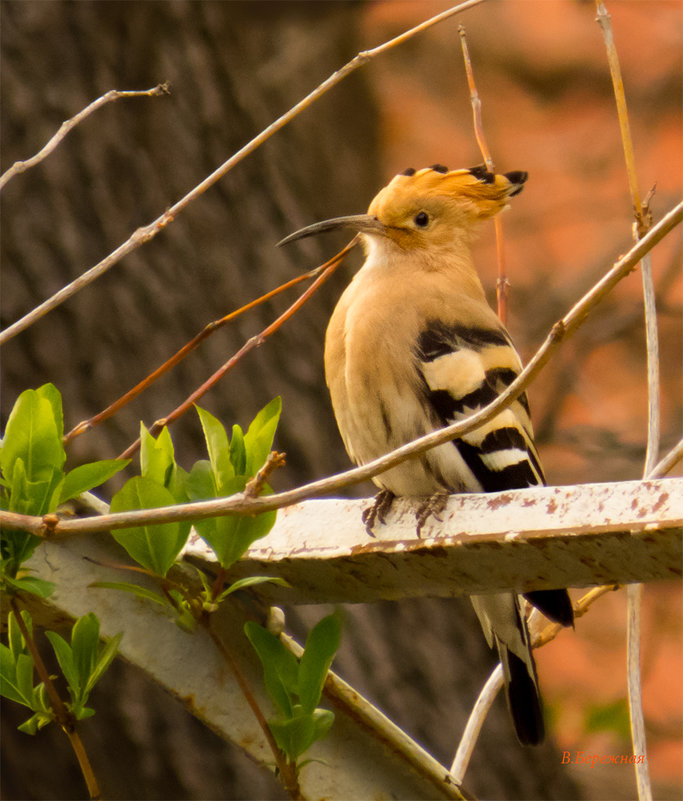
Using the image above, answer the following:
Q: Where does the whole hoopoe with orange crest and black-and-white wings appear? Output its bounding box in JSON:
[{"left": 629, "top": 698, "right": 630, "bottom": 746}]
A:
[{"left": 280, "top": 164, "right": 573, "bottom": 745}]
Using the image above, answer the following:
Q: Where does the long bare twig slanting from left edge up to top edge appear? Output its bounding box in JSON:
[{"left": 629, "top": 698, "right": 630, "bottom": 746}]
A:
[{"left": 0, "top": 0, "right": 484, "bottom": 345}]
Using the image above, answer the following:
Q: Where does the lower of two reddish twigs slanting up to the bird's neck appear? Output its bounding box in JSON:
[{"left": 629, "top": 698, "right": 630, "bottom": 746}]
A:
[{"left": 118, "top": 241, "right": 358, "bottom": 459}]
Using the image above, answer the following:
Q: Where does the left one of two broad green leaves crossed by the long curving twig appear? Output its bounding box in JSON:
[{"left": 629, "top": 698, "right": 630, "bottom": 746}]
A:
[{"left": 111, "top": 476, "right": 190, "bottom": 576}]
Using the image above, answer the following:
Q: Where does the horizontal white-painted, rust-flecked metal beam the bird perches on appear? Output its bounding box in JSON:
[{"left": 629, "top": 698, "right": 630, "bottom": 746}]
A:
[{"left": 186, "top": 478, "right": 683, "bottom": 604}]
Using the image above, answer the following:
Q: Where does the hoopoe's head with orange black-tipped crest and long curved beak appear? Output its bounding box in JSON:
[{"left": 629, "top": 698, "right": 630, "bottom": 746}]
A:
[{"left": 279, "top": 164, "right": 527, "bottom": 250}]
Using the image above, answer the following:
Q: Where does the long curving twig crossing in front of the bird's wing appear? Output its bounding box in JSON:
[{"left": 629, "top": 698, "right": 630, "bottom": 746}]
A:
[{"left": 0, "top": 202, "right": 683, "bottom": 536}]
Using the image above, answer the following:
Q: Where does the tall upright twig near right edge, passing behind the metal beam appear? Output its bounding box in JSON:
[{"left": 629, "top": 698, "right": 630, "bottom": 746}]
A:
[{"left": 596, "top": 0, "right": 660, "bottom": 801}]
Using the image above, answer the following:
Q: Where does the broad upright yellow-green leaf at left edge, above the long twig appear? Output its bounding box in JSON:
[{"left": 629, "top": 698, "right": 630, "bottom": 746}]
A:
[{"left": 0, "top": 388, "right": 66, "bottom": 482}]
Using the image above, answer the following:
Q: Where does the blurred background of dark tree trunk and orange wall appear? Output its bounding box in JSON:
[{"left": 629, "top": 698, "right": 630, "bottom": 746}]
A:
[{"left": 0, "top": 0, "right": 683, "bottom": 799}]
